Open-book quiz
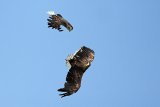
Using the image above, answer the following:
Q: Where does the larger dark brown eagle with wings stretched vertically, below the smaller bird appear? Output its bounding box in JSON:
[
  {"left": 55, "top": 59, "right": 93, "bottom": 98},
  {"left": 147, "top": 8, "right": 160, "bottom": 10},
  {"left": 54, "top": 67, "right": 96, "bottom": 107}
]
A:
[{"left": 58, "top": 46, "right": 95, "bottom": 98}]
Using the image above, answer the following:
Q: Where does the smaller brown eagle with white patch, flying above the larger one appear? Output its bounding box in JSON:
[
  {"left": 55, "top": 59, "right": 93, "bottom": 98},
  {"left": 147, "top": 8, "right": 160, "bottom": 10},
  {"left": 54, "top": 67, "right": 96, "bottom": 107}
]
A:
[{"left": 47, "top": 11, "right": 73, "bottom": 32}]
